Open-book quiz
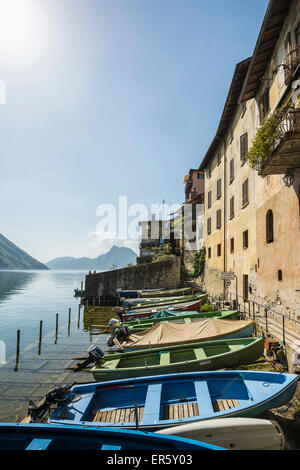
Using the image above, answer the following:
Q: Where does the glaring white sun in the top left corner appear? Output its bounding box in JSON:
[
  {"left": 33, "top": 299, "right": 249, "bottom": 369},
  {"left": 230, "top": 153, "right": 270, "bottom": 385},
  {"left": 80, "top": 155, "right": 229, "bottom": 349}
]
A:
[{"left": 0, "top": 0, "right": 47, "bottom": 67}]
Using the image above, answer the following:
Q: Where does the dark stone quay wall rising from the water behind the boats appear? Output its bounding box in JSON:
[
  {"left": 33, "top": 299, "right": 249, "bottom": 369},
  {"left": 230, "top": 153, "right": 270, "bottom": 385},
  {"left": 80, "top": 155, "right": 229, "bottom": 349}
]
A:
[{"left": 85, "top": 256, "right": 181, "bottom": 301}]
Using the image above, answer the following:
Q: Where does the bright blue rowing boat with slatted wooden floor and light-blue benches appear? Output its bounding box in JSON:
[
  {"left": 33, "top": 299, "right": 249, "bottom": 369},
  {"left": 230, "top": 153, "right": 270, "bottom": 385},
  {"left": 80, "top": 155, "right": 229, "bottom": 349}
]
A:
[{"left": 49, "top": 370, "right": 298, "bottom": 431}]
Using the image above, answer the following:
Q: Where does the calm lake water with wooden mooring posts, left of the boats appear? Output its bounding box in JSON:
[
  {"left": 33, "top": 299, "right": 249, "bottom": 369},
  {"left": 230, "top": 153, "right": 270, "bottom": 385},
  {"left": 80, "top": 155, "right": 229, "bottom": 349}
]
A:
[{"left": 0, "top": 270, "right": 106, "bottom": 421}]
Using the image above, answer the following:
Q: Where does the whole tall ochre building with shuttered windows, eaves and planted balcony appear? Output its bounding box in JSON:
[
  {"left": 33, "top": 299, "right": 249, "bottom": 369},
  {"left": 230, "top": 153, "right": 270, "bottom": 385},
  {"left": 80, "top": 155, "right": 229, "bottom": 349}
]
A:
[{"left": 199, "top": 0, "right": 300, "bottom": 317}]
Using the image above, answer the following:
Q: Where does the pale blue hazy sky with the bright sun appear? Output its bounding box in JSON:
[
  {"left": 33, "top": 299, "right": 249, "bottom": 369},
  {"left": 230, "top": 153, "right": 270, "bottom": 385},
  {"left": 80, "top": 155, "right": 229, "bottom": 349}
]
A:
[{"left": 0, "top": 0, "right": 268, "bottom": 261}]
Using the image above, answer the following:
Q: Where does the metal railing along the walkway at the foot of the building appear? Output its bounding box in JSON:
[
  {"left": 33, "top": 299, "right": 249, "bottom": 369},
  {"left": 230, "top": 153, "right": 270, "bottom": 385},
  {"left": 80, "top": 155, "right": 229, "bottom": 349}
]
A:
[{"left": 208, "top": 292, "right": 300, "bottom": 344}]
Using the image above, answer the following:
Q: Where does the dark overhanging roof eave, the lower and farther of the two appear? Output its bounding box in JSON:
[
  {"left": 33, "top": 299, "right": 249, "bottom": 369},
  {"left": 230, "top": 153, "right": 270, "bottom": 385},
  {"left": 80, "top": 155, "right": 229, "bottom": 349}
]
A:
[{"left": 199, "top": 57, "right": 251, "bottom": 170}]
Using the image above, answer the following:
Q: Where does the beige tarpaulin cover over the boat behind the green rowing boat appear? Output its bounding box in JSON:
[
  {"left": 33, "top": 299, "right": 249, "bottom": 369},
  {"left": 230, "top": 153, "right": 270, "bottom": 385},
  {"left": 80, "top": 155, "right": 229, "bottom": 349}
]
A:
[{"left": 122, "top": 318, "right": 254, "bottom": 349}]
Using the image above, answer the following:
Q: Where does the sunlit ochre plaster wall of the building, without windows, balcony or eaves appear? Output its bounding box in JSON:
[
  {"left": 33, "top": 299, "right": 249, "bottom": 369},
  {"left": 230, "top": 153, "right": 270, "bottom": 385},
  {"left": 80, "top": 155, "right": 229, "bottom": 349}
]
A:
[{"left": 204, "top": 0, "right": 300, "bottom": 315}]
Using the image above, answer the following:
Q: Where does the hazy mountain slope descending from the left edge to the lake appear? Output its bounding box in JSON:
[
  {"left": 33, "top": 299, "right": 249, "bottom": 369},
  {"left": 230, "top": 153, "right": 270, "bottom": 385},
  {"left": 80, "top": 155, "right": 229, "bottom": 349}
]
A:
[{"left": 0, "top": 233, "right": 48, "bottom": 269}]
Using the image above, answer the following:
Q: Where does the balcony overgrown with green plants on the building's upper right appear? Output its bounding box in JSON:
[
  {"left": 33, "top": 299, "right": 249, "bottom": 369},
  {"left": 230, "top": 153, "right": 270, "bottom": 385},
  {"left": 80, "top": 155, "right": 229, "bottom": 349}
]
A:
[{"left": 254, "top": 107, "right": 300, "bottom": 176}]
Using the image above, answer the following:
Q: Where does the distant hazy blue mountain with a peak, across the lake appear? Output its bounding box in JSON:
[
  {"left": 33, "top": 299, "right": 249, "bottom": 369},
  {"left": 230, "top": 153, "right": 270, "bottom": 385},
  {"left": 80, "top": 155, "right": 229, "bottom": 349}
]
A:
[{"left": 46, "top": 245, "right": 137, "bottom": 271}]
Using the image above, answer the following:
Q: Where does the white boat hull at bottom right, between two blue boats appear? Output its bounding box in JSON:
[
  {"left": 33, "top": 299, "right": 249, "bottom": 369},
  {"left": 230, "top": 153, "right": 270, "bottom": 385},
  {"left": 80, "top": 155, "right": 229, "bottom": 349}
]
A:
[{"left": 156, "top": 418, "right": 285, "bottom": 450}]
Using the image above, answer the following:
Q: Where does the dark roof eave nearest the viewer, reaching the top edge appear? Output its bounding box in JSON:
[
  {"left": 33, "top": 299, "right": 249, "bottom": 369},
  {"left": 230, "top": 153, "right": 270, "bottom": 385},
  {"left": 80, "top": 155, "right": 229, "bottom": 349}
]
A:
[{"left": 239, "top": 0, "right": 292, "bottom": 103}]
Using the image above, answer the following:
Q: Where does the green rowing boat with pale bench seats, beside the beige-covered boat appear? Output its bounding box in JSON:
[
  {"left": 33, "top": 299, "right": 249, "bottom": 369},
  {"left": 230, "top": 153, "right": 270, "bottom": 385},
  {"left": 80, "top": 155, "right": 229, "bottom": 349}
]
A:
[{"left": 92, "top": 337, "right": 264, "bottom": 382}]
